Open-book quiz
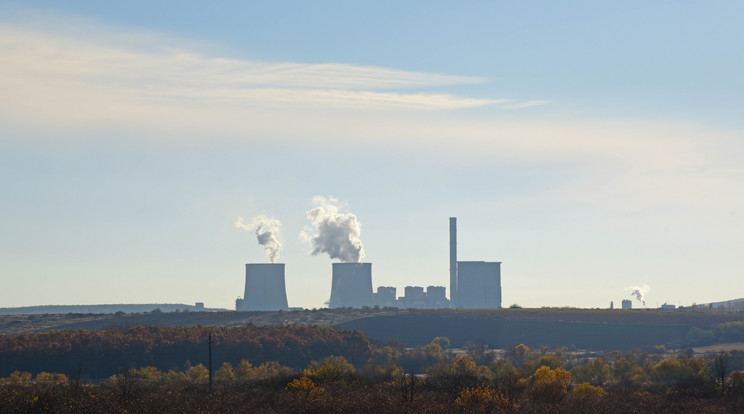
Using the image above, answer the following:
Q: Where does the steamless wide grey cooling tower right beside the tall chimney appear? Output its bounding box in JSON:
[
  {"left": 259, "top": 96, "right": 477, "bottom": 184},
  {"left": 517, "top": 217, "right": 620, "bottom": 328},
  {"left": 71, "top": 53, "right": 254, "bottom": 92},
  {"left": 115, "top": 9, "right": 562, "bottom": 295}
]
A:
[{"left": 457, "top": 262, "right": 501, "bottom": 308}]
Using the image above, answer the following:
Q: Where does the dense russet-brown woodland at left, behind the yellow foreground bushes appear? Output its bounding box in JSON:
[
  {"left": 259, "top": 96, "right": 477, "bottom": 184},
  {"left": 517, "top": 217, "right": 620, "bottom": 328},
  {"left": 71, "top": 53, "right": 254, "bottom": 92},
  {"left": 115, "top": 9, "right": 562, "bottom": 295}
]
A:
[{"left": 0, "top": 325, "right": 374, "bottom": 380}]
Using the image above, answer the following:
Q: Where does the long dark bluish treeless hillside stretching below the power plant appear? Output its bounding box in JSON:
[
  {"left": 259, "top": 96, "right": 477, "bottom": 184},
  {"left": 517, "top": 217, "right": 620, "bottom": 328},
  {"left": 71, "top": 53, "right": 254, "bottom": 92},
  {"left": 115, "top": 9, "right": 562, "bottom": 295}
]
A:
[{"left": 0, "top": 308, "right": 744, "bottom": 349}]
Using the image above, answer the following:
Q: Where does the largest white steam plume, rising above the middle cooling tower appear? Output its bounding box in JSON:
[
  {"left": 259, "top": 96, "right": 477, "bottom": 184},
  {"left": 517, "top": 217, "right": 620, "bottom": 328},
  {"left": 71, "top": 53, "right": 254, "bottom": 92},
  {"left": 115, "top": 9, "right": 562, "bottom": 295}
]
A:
[{"left": 300, "top": 196, "right": 364, "bottom": 263}]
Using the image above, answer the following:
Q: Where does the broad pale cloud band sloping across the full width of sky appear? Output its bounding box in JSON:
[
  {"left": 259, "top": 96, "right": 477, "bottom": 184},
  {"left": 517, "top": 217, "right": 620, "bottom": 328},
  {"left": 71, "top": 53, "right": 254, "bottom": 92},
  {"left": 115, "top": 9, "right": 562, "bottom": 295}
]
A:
[{"left": 0, "top": 18, "right": 741, "bottom": 223}]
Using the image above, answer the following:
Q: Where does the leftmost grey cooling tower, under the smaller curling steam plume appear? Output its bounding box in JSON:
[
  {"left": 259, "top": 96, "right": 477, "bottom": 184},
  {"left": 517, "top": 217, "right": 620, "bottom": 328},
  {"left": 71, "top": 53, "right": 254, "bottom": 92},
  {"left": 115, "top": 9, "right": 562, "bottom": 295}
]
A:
[{"left": 244, "top": 263, "right": 289, "bottom": 311}]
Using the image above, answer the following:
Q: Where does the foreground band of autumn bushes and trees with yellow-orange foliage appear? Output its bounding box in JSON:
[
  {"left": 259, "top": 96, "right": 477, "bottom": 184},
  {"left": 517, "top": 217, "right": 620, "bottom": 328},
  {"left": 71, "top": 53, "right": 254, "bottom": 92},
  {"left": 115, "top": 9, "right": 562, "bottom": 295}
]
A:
[{"left": 0, "top": 334, "right": 744, "bottom": 413}]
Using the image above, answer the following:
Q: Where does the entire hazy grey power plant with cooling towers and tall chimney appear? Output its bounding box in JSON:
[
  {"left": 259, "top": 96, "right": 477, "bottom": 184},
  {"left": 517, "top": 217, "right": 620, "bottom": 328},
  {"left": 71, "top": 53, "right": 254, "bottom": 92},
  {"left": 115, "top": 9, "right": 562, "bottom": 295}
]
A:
[{"left": 235, "top": 217, "right": 501, "bottom": 311}]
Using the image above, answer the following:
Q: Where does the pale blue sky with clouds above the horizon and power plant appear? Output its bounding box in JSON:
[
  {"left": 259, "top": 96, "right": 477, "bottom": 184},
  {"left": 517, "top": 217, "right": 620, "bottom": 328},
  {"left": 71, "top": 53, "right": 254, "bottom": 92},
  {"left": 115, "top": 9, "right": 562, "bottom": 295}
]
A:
[{"left": 0, "top": 0, "right": 744, "bottom": 308}]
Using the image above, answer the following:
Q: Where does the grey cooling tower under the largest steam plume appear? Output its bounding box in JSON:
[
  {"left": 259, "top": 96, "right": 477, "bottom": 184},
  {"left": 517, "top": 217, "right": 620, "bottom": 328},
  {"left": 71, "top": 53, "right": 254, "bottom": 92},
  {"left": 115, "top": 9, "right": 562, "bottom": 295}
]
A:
[{"left": 329, "top": 263, "right": 375, "bottom": 308}]
